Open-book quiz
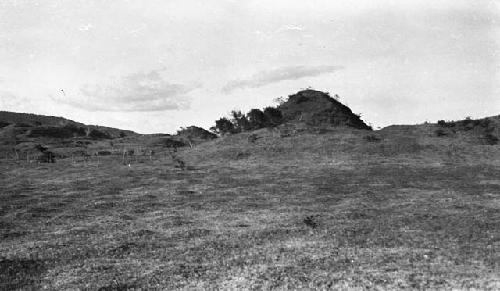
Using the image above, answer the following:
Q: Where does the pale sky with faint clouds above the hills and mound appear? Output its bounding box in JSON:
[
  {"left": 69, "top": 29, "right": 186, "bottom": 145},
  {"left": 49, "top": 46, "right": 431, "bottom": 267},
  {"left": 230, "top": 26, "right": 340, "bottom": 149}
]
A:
[{"left": 0, "top": 0, "right": 500, "bottom": 133}]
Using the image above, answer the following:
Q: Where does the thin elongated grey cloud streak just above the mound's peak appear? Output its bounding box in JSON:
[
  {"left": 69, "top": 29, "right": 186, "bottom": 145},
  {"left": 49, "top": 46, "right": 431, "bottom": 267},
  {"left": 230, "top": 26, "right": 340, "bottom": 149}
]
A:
[{"left": 222, "top": 66, "right": 343, "bottom": 93}]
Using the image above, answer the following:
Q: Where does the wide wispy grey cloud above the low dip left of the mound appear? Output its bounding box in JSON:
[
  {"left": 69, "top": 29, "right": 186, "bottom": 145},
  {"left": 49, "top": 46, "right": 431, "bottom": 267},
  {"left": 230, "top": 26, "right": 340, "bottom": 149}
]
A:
[{"left": 51, "top": 71, "right": 199, "bottom": 112}]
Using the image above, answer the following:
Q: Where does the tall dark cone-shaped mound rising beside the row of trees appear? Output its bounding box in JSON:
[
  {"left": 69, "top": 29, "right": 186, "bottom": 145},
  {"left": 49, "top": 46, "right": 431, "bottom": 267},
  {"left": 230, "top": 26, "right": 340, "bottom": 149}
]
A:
[{"left": 278, "top": 90, "right": 371, "bottom": 129}]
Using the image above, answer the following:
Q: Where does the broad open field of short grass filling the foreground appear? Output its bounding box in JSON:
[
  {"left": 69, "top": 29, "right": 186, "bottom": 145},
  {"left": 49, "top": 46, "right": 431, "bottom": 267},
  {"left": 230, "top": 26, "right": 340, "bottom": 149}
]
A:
[{"left": 0, "top": 131, "right": 500, "bottom": 290}]
